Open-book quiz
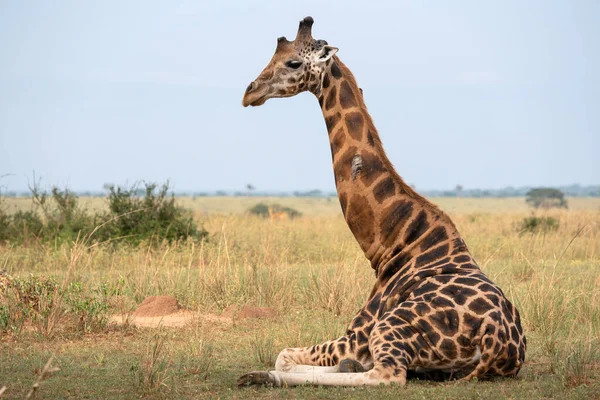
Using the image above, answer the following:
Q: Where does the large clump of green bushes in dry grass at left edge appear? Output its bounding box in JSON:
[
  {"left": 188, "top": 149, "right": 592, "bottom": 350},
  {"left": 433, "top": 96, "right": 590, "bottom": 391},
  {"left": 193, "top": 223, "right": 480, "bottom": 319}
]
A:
[{"left": 0, "top": 183, "right": 208, "bottom": 245}]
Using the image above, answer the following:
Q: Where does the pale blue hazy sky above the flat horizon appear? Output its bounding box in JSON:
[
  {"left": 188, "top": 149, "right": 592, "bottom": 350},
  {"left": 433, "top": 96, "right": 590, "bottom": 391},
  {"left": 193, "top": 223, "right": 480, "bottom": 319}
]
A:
[{"left": 0, "top": 0, "right": 600, "bottom": 191}]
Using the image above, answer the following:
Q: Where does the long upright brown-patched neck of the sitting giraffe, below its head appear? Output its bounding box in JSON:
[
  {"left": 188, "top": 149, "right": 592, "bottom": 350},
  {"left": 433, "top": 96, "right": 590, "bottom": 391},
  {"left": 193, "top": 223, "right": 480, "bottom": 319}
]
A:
[{"left": 317, "top": 57, "right": 466, "bottom": 278}]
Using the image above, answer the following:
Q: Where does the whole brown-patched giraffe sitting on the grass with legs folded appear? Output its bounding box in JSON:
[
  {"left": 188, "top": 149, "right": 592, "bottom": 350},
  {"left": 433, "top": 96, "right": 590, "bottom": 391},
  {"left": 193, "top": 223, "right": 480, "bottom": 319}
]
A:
[{"left": 238, "top": 17, "right": 526, "bottom": 386}]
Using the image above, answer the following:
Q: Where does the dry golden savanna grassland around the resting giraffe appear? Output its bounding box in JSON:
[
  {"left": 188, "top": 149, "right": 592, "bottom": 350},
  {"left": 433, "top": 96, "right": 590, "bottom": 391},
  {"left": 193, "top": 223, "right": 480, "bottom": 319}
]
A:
[{"left": 0, "top": 198, "right": 600, "bottom": 399}]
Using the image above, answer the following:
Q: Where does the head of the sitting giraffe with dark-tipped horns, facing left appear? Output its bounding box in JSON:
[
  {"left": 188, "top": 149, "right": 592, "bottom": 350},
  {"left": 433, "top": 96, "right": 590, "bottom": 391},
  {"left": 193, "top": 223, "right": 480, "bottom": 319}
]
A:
[{"left": 242, "top": 17, "right": 338, "bottom": 107}]
